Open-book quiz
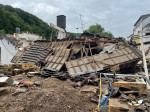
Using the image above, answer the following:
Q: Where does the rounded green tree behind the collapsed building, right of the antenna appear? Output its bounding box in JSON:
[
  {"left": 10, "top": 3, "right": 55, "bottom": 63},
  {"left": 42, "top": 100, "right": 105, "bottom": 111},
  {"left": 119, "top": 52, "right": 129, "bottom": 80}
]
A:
[{"left": 84, "top": 24, "right": 113, "bottom": 37}]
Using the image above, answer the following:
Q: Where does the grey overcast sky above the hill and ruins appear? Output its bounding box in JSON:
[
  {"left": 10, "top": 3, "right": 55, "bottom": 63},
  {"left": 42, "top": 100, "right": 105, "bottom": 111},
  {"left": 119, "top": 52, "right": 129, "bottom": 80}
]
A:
[{"left": 0, "top": 0, "right": 150, "bottom": 37}]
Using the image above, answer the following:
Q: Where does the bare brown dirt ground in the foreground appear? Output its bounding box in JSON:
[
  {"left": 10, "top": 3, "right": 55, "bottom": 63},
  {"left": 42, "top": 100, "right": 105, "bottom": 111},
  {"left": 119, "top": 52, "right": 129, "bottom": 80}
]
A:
[{"left": 0, "top": 75, "right": 97, "bottom": 112}]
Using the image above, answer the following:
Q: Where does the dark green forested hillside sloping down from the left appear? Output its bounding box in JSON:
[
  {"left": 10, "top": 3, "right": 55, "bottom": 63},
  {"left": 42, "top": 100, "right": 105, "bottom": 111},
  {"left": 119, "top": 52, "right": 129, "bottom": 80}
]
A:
[{"left": 0, "top": 4, "right": 55, "bottom": 39}]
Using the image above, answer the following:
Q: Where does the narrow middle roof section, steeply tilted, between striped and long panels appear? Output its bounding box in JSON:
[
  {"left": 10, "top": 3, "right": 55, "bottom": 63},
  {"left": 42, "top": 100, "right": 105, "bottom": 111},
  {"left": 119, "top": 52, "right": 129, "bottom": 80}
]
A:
[{"left": 45, "top": 41, "right": 72, "bottom": 71}]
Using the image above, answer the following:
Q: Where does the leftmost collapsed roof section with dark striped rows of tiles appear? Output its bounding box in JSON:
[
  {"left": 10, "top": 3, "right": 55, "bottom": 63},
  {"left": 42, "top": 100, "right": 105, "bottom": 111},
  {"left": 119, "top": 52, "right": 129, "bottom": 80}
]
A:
[{"left": 12, "top": 44, "right": 51, "bottom": 65}]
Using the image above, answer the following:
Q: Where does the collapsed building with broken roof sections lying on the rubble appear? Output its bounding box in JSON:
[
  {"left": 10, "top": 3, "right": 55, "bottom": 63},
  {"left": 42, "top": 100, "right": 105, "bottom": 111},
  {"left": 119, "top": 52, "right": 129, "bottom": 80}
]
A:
[{"left": 11, "top": 33, "right": 142, "bottom": 76}]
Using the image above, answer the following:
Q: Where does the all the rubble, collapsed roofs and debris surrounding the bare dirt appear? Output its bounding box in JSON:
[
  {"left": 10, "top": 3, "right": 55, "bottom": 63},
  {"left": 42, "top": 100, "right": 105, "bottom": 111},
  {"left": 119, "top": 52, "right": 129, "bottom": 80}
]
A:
[{"left": 0, "top": 33, "right": 150, "bottom": 112}]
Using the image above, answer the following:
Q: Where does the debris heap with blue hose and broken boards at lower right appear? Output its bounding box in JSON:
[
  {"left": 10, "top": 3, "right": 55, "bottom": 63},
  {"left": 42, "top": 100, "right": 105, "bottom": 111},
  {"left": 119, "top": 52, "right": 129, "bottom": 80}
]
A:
[{"left": 91, "top": 73, "right": 150, "bottom": 112}]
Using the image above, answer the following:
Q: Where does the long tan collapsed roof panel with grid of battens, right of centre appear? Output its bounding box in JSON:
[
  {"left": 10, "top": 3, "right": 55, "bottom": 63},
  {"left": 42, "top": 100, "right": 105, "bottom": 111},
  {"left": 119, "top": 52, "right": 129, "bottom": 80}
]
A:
[{"left": 65, "top": 47, "right": 141, "bottom": 76}]
